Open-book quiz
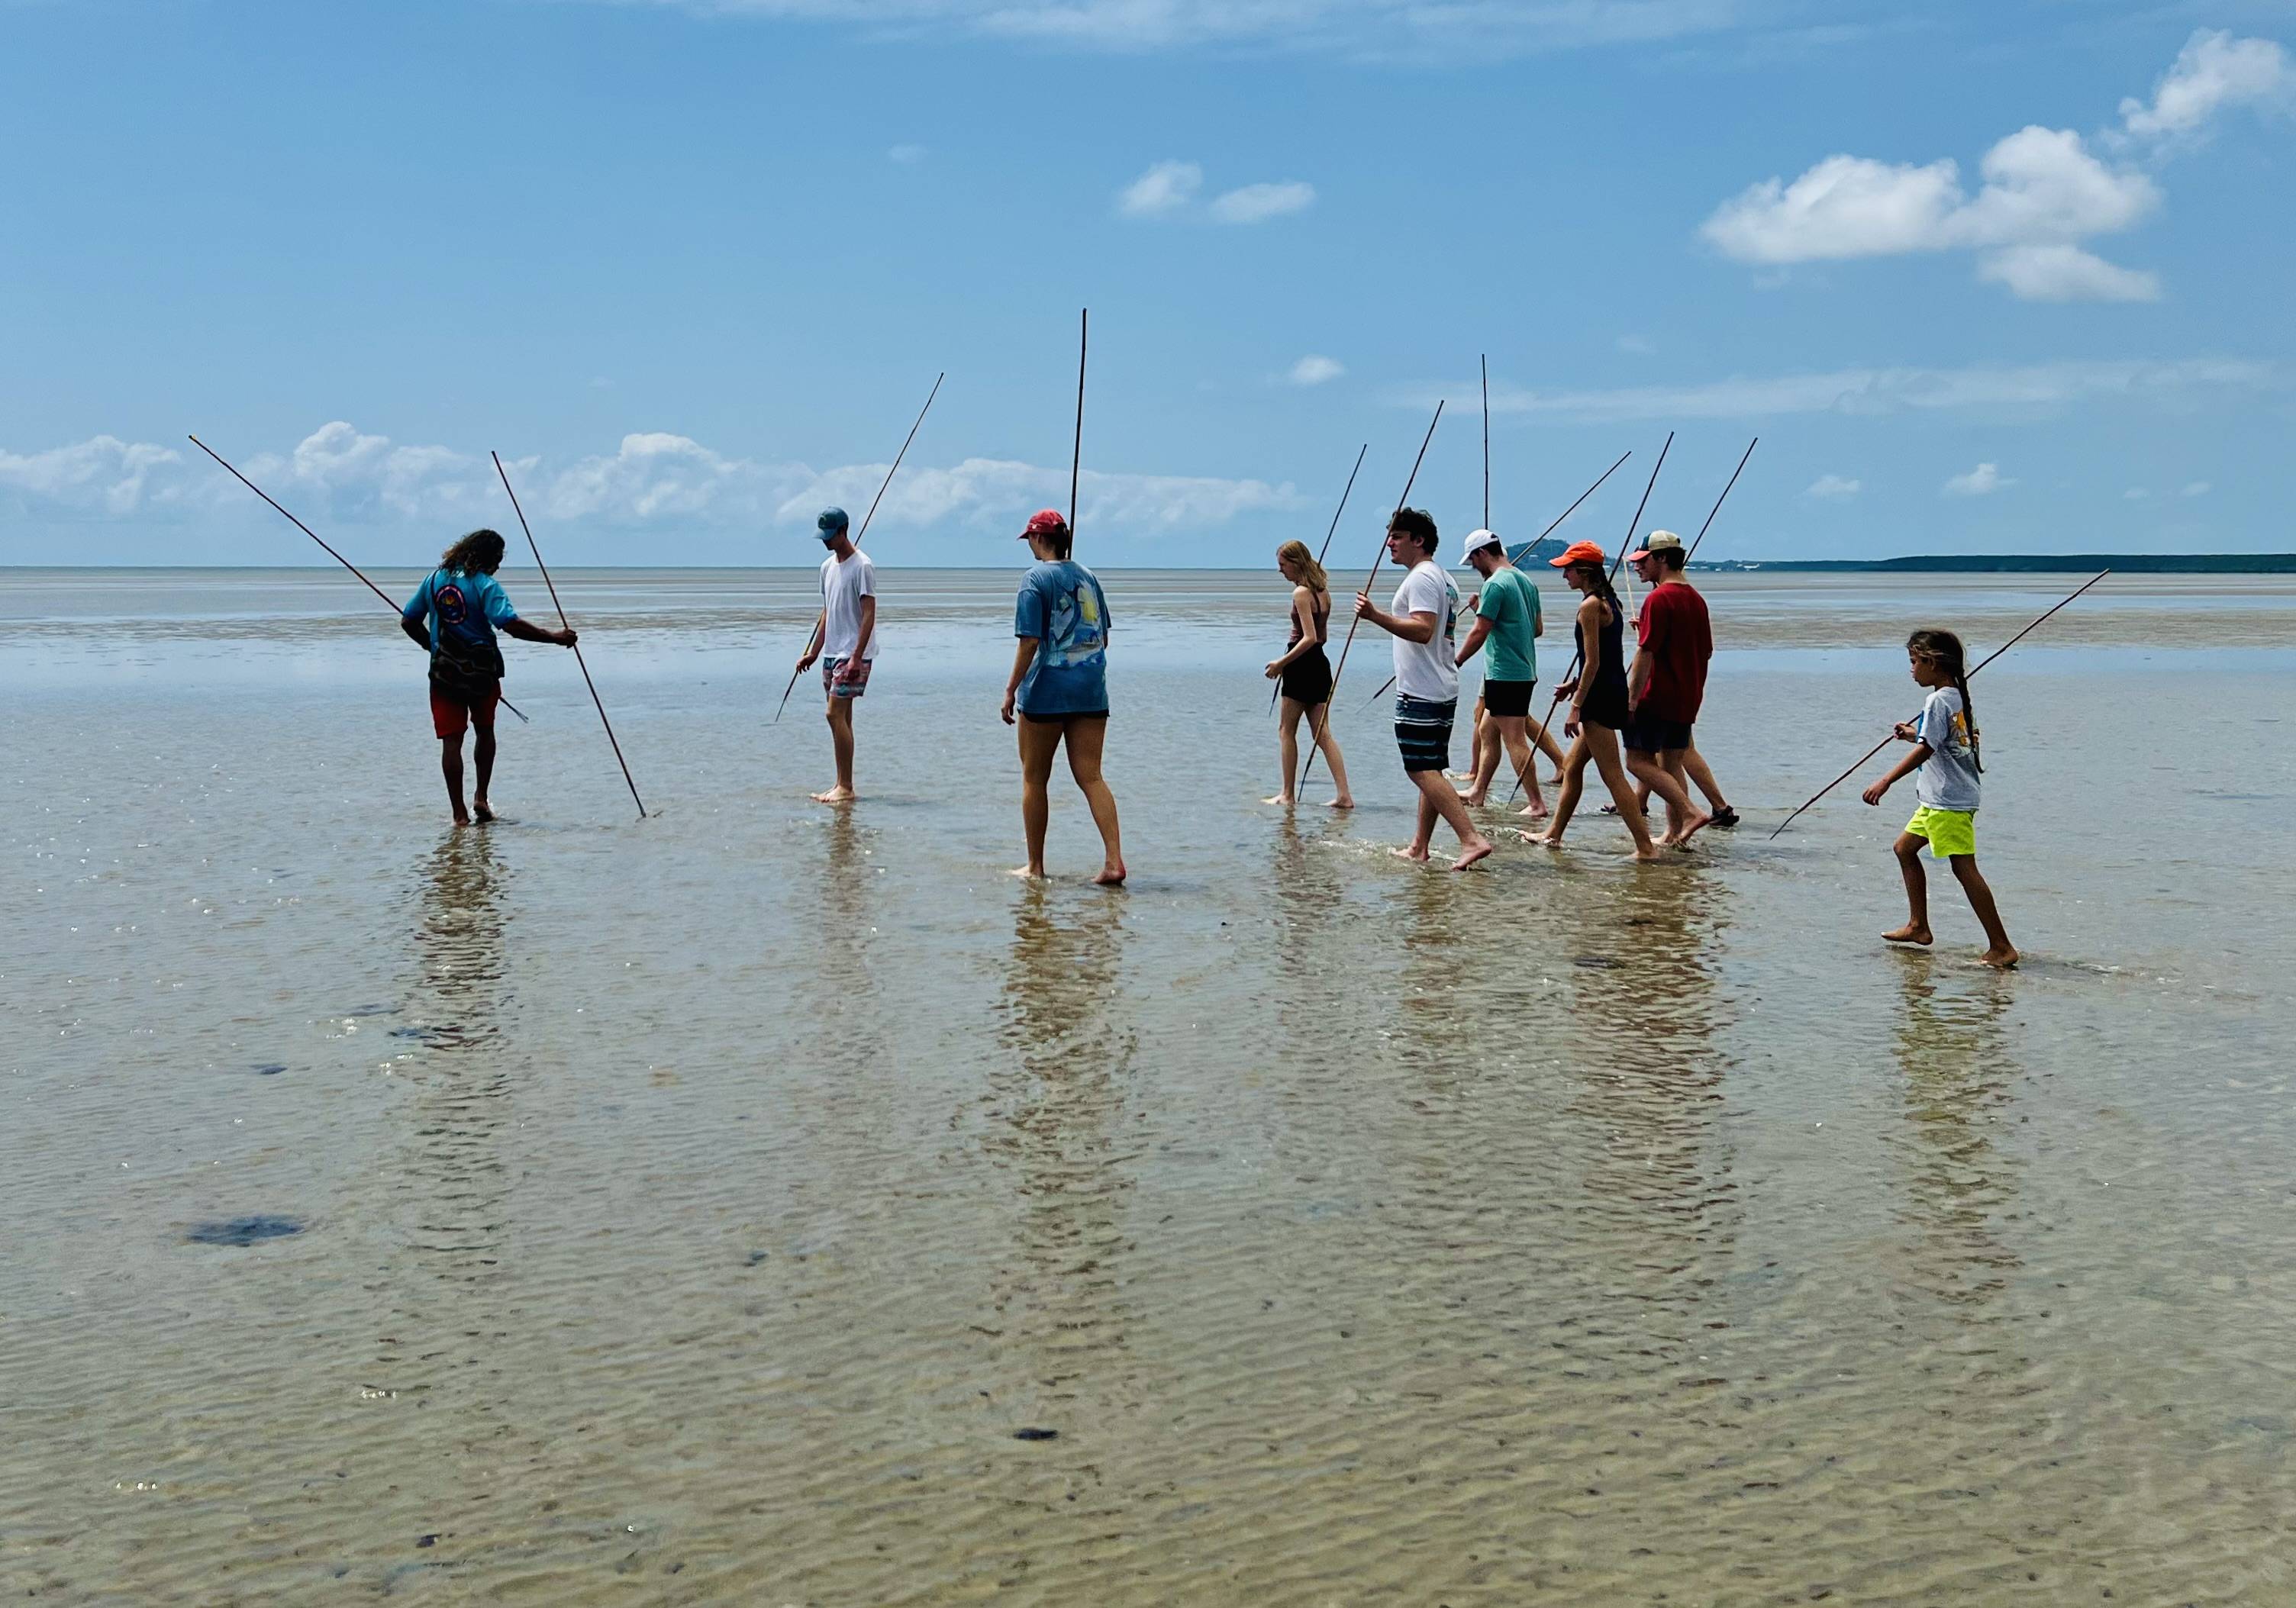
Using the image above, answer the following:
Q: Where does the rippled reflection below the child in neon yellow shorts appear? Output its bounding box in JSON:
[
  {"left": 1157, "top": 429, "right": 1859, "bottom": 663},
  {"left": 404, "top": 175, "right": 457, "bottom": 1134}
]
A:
[{"left": 1890, "top": 951, "right": 2018, "bottom": 1307}]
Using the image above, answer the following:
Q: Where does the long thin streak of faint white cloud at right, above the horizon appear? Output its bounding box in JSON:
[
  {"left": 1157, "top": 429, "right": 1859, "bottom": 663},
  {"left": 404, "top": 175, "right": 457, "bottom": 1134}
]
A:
[{"left": 1451, "top": 359, "right": 2287, "bottom": 423}]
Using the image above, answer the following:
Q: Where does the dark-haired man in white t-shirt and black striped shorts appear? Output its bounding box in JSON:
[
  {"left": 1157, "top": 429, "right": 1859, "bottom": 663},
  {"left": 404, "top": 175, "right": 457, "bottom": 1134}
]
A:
[{"left": 1355, "top": 508, "right": 1490, "bottom": 871}]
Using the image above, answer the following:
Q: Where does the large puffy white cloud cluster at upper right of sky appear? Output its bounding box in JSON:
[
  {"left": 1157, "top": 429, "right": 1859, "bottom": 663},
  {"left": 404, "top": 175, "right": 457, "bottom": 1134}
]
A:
[{"left": 1699, "top": 32, "right": 2289, "bottom": 301}]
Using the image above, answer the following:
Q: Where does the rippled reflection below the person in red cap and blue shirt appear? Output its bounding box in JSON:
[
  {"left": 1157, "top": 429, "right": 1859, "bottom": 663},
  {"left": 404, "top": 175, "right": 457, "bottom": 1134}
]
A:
[{"left": 987, "top": 887, "right": 1139, "bottom": 1406}]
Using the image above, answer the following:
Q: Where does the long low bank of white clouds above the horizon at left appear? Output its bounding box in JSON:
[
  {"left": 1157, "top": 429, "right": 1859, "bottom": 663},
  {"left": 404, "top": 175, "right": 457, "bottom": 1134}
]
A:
[{"left": 0, "top": 421, "right": 1304, "bottom": 537}]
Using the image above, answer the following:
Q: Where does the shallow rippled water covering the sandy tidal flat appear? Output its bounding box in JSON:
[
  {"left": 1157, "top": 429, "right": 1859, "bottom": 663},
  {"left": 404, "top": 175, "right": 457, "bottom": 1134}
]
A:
[{"left": 0, "top": 569, "right": 2296, "bottom": 1603}]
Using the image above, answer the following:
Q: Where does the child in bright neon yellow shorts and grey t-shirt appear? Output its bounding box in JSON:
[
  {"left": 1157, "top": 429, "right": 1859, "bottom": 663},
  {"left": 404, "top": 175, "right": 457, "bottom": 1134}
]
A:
[{"left": 1862, "top": 632, "right": 2018, "bottom": 969}]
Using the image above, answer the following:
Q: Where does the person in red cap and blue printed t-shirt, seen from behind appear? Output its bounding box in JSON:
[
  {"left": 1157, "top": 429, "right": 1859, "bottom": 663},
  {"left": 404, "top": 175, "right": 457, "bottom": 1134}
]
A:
[{"left": 1001, "top": 508, "right": 1125, "bottom": 887}]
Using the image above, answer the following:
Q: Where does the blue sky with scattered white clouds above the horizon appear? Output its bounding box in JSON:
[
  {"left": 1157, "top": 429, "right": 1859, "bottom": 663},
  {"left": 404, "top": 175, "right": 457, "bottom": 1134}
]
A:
[{"left": 0, "top": 0, "right": 2296, "bottom": 567}]
